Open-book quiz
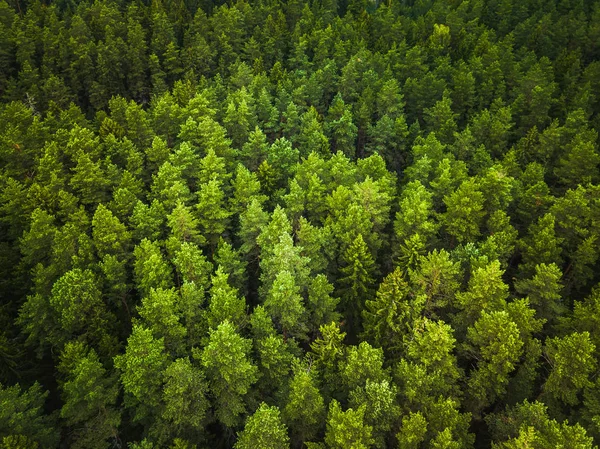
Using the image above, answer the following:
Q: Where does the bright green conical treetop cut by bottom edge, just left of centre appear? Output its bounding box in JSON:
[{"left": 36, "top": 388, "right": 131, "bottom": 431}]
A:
[{"left": 233, "top": 402, "right": 290, "bottom": 449}]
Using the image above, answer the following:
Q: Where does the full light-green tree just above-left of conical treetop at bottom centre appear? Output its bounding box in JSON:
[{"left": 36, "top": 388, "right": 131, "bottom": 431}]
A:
[{"left": 199, "top": 321, "right": 258, "bottom": 427}]
